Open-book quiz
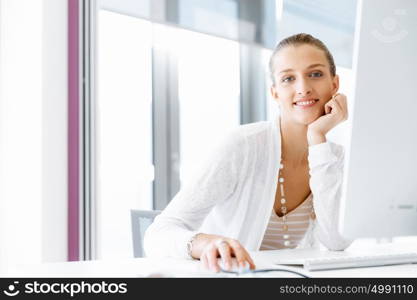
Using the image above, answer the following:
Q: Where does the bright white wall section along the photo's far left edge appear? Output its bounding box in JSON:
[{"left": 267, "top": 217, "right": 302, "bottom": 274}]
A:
[{"left": 0, "top": 0, "right": 42, "bottom": 272}]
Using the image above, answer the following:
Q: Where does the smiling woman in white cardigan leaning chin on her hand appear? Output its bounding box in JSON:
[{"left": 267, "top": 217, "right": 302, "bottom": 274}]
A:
[{"left": 144, "top": 34, "right": 350, "bottom": 271}]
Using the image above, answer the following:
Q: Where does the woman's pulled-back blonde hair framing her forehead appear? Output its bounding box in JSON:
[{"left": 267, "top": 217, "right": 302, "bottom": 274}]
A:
[{"left": 269, "top": 33, "right": 336, "bottom": 85}]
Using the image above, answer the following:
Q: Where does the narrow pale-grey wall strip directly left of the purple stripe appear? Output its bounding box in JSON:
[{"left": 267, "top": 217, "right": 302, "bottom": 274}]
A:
[{"left": 42, "top": 0, "right": 68, "bottom": 261}]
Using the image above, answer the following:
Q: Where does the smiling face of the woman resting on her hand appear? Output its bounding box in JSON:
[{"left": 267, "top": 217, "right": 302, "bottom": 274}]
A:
[{"left": 271, "top": 45, "right": 339, "bottom": 125}]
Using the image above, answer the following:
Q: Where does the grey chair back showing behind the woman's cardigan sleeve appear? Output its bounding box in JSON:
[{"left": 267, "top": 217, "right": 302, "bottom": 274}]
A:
[{"left": 130, "top": 209, "right": 161, "bottom": 257}]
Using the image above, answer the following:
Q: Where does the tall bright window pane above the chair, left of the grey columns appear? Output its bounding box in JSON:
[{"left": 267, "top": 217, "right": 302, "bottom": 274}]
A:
[{"left": 96, "top": 10, "right": 153, "bottom": 258}]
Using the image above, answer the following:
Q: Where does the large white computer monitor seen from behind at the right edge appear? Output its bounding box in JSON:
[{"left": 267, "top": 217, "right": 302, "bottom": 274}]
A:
[{"left": 339, "top": 0, "right": 417, "bottom": 238}]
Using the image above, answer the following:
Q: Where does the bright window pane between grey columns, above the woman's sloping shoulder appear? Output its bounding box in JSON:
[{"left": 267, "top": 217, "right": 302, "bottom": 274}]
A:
[{"left": 177, "top": 29, "right": 240, "bottom": 182}]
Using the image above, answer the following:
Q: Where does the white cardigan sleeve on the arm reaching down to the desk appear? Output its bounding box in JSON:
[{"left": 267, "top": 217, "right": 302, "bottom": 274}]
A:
[{"left": 144, "top": 130, "right": 247, "bottom": 258}]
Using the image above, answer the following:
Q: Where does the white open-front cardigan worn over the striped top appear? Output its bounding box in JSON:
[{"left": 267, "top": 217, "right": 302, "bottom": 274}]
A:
[{"left": 144, "top": 120, "right": 351, "bottom": 258}]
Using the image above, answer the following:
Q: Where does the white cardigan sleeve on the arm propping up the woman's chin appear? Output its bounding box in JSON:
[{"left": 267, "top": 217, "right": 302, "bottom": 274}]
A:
[{"left": 308, "top": 142, "right": 352, "bottom": 250}]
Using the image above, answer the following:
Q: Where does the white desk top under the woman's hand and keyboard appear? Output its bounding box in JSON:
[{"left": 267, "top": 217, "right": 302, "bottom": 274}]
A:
[{"left": 8, "top": 242, "right": 417, "bottom": 277}]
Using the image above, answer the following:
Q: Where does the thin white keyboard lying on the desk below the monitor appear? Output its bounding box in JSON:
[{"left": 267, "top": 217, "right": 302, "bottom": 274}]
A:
[{"left": 303, "top": 253, "right": 417, "bottom": 271}]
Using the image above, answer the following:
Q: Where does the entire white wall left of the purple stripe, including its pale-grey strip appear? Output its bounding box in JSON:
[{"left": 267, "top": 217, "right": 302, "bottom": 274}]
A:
[{"left": 0, "top": 0, "right": 67, "bottom": 274}]
